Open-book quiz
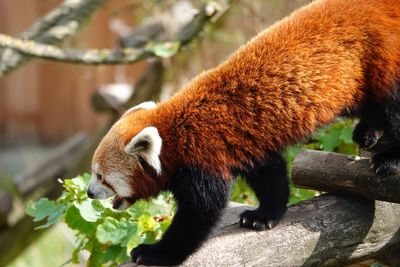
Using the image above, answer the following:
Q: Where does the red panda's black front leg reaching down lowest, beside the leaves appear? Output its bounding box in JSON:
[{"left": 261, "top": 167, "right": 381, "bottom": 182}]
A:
[{"left": 131, "top": 168, "right": 230, "bottom": 265}]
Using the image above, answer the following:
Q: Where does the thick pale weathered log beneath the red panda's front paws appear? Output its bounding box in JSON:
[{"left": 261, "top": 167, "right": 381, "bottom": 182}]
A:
[{"left": 122, "top": 197, "right": 400, "bottom": 267}]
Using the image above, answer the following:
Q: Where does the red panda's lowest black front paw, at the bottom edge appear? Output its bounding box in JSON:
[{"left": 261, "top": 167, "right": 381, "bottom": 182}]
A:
[{"left": 131, "top": 244, "right": 183, "bottom": 266}]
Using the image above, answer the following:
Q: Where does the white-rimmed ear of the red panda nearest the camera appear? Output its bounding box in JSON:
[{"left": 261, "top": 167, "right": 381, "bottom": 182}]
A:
[{"left": 124, "top": 126, "right": 162, "bottom": 175}]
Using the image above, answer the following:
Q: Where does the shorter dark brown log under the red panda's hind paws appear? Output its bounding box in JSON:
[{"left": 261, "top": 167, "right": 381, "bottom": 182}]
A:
[{"left": 292, "top": 150, "right": 400, "bottom": 203}]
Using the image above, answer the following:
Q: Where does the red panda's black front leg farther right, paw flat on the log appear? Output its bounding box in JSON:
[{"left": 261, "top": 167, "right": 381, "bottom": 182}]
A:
[{"left": 236, "top": 153, "right": 289, "bottom": 230}]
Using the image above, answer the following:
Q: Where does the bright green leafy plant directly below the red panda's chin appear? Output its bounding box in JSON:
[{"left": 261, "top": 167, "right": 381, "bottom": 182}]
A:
[{"left": 26, "top": 174, "right": 174, "bottom": 266}]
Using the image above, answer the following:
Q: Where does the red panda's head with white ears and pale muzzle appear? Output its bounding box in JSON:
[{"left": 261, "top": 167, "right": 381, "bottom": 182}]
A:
[{"left": 88, "top": 102, "right": 162, "bottom": 209}]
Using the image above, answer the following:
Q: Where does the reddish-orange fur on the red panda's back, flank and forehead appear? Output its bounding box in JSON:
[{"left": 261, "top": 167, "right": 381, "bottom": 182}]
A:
[{"left": 95, "top": 0, "right": 400, "bottom": 195}]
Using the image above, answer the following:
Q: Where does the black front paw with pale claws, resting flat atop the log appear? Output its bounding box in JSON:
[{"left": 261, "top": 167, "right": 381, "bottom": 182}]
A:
[{"left": 239, "top": 209, "right": 284, "bottom": 231}]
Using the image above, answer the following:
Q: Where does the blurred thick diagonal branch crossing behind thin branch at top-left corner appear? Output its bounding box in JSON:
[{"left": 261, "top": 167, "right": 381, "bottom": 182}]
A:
[{"left": 0, "top": 0, "right": 104, "bottom": 77}]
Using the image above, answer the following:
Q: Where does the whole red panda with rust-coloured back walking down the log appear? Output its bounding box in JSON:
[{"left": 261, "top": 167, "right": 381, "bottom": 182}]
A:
[{"left": 88, "top": 0, "right": 400, "bottom": 265}]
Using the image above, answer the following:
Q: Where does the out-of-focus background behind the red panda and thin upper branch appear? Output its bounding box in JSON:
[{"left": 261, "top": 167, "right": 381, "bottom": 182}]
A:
[{"left": 0, "top": 0, "right": 372, "bottom": 266}]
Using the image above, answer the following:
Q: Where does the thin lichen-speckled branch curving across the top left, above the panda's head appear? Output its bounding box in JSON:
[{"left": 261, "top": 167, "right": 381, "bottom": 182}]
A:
[{"left": 0, "top": 2, "right": 222, "bottom": 65}]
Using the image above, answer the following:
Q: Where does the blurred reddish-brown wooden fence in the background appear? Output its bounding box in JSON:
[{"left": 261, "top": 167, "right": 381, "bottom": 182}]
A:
[{"left": 0, "top": 0, "right": 144, "bottom": 145}]
